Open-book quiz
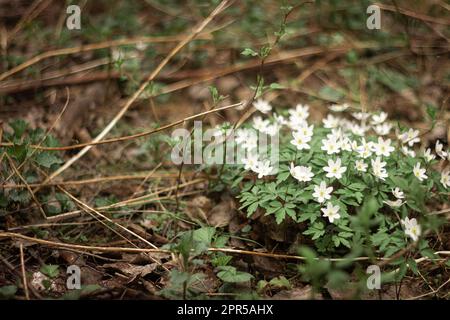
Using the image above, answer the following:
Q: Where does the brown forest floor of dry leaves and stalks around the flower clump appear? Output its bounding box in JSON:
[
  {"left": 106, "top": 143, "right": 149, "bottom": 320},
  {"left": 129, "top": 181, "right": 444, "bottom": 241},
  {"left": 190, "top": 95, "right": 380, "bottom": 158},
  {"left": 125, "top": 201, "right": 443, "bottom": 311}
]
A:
[{"left": 0, "top": 0, "right": 450, "bottom": 299}]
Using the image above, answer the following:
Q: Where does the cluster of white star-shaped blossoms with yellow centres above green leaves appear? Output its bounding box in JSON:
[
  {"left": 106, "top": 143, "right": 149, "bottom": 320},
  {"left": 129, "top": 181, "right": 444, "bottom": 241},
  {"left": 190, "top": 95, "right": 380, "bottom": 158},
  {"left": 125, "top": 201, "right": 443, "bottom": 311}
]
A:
[{"left": 243, "top": 99, "right": 450, "bottom": 241}]
